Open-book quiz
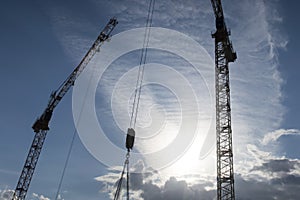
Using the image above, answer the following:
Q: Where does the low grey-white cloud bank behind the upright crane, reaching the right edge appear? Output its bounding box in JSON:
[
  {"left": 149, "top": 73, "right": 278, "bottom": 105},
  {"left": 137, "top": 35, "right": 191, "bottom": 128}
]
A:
[{"left": 96, "top": 155, "right": 300, "bottom": 200}]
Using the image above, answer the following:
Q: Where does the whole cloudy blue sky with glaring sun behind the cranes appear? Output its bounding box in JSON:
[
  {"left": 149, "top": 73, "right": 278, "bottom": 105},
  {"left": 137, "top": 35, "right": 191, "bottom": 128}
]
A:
[{"left": 0, "top": 0, "right": 300, "bottom": 200}]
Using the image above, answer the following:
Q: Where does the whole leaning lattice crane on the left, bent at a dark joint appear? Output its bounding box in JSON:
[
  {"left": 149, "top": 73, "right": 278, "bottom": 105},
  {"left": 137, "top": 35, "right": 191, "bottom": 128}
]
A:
[{"left": 12, "top": 18, "right": 118, "bottom": 200}]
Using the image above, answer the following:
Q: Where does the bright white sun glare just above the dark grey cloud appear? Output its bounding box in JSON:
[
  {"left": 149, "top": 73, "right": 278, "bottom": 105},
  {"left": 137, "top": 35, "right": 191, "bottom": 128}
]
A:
[{"left": 136, "top": 117, "right": 215, "bottom": 181}]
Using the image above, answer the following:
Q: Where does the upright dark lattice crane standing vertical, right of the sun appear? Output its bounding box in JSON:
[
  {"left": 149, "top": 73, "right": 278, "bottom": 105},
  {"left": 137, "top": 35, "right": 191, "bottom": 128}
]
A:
[{"left": 211, "top": 0, "right": 237, "bottom": 200}]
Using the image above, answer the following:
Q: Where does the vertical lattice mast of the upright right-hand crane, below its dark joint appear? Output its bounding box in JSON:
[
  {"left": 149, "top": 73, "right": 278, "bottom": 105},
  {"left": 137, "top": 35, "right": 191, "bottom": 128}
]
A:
[{"left": 215, "top": 37, "right": 235, "bottom": 200}]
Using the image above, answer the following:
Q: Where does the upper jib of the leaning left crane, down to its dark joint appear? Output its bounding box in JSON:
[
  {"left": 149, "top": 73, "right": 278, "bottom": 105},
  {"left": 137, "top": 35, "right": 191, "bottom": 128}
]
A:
[{"left": 32, "top": 18, "right": 118, "bottom": 133}]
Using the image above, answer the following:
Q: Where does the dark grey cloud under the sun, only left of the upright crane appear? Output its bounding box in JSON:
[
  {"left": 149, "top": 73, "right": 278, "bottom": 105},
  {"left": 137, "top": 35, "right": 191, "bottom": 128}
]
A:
[{"left": 95, "top": 162, "right": 215, "bottom": 200}]
